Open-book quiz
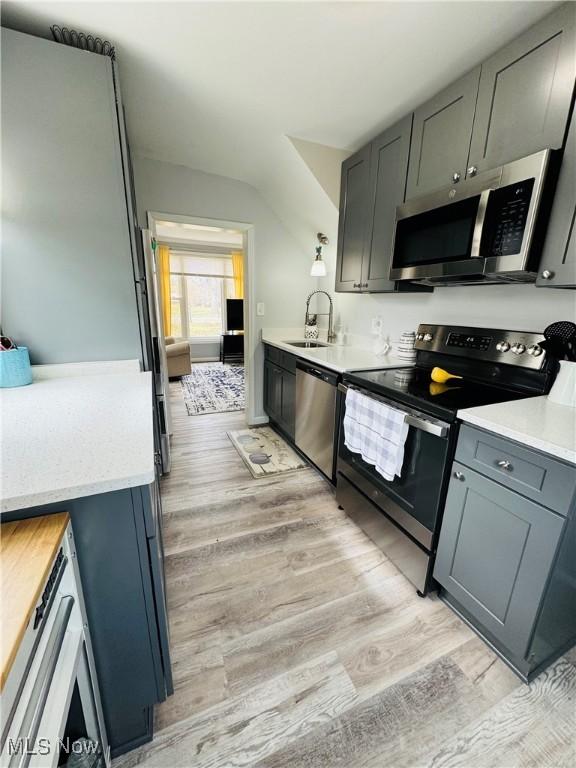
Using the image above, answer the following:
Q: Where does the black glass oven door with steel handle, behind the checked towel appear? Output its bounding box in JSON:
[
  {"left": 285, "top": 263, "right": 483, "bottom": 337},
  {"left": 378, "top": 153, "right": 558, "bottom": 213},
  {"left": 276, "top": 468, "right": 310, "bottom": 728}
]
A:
[{"left": 338, "top": 384, "right": 453, "bottom": 550}]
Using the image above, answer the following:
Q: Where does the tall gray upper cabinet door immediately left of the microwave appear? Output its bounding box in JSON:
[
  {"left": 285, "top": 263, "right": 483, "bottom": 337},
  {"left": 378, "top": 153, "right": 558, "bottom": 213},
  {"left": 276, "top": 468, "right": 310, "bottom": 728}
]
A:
[{"left": 361, "top": 115, "right": 412, "bottom": 291}]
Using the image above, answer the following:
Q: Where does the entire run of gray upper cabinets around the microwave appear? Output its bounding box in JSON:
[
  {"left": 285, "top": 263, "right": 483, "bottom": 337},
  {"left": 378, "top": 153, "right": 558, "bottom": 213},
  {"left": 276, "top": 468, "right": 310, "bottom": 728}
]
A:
[{"left": 336, "top": 3, "right": 576, "bottom": 292}]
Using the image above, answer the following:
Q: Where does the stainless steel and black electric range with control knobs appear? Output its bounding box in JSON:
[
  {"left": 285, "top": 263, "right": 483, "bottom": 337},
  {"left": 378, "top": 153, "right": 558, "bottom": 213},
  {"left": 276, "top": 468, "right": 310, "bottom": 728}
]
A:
[{"left": 336, "top": 325, "right": 555, "bottom": 596}]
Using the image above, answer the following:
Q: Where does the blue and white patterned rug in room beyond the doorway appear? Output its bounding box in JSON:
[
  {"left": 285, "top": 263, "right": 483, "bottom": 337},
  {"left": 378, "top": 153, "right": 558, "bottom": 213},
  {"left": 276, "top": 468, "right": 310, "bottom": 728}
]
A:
[{"left": 181, "top": 363, "right": 245, "bottom": 416}]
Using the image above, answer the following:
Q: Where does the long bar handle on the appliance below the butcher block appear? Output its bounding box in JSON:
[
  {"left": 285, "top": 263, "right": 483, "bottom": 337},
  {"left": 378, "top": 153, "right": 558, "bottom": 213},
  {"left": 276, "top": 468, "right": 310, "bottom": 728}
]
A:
[{"left": 9, "top": 595, "right": 74, "bottom": 768}]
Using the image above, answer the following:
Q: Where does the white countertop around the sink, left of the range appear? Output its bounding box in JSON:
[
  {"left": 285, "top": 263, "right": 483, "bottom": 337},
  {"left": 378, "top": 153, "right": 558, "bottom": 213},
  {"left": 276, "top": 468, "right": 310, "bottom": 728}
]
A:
[{"left": 262, "top": 330, "right": 412, "bottom": 373}]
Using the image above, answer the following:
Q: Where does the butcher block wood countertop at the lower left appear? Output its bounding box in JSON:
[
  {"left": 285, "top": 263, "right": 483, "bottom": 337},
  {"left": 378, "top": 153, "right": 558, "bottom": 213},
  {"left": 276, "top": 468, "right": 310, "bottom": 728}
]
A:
[{"left": 0, "top": 512, "right": 69, "bottom": 690}]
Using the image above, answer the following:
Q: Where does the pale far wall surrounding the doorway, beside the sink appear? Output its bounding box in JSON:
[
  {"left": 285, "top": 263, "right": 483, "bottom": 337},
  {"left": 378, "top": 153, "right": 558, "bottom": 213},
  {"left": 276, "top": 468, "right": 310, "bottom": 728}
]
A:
[{"left": 133, "top": 154, "right": 315, "bottom": 417}]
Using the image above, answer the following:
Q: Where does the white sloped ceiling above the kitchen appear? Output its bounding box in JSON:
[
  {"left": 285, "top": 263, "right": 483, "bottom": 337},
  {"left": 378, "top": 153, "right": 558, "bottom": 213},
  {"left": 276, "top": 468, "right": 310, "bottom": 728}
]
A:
[{"left": 2, "top": 1, "right": 557, "bottom": 249}]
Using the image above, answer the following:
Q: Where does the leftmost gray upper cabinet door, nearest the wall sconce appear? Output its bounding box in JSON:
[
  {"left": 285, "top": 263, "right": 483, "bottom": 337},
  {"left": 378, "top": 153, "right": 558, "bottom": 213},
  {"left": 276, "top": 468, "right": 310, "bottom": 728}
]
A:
[{"left": 336, "top": 144, "right": 370, "bottom": 291}]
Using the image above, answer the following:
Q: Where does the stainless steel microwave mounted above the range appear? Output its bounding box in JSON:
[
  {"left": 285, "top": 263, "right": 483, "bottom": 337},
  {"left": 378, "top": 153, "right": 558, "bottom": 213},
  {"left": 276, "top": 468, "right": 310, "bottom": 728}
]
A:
[{"left": 390, "top": 149, "right": 556, "bottom": 285}]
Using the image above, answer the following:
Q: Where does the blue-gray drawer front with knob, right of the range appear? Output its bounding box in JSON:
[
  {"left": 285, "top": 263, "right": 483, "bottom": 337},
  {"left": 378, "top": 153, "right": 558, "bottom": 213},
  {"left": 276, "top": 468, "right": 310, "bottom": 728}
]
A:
[{"left": 456, "top": 425, "right": 576, "bottom": 516}]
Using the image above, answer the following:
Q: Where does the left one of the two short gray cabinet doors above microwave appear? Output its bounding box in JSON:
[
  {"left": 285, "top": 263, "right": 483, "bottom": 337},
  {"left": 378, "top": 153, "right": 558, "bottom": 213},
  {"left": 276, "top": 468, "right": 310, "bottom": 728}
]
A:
[{"left": 406, "top": 67, "right": 480, "bottom": 199}]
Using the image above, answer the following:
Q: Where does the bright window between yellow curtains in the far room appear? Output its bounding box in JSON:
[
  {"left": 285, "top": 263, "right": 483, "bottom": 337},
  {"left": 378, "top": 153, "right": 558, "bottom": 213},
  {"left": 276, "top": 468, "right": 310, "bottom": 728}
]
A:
[{"left": 170, "top": 251, "right": 236, "bottom": 338}]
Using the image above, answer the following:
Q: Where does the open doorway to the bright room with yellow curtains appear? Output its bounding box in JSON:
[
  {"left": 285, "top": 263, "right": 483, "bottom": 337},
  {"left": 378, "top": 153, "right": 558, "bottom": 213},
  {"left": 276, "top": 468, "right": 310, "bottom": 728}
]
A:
[{"left": 148, "top": 212, "right": 254, "bottom": 423}]
